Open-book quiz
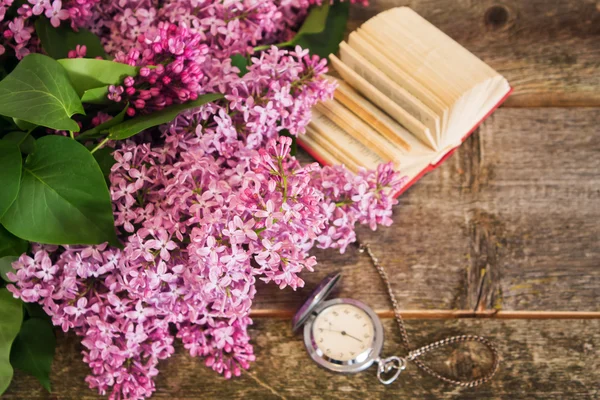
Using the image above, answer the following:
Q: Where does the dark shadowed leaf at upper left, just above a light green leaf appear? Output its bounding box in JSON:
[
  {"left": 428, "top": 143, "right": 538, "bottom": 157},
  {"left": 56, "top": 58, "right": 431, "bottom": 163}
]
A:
[{"left": 35, "top": 17, "right": 106, "bottom": 60}]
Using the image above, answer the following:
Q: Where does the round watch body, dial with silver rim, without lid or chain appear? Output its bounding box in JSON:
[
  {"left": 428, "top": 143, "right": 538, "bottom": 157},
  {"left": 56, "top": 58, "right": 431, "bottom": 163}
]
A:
[{"left": 304, "top": 299, "right": 383, "bottom": 372}]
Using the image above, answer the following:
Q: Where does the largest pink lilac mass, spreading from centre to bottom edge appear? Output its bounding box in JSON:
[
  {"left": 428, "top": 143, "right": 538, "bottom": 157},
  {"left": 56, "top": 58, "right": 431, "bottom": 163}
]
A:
[{"left": 9, "top": 137, "right": 402, "bottom": 399}]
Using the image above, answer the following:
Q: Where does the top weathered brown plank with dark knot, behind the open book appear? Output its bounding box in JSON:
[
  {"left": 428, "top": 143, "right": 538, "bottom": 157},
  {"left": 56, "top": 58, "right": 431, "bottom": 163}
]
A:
[{"left": 350, "top": 0, "right": 600, "bottom": 107}]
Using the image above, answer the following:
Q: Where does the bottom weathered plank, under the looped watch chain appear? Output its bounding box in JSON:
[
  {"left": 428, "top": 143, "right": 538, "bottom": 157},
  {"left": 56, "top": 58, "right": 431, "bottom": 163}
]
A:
[{"left": 3, "top": 319, "right": 600, "bottom": 400}]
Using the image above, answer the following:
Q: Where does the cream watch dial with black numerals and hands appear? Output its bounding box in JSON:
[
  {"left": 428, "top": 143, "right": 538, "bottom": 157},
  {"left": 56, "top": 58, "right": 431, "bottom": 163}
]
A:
[{"left": 312, "top": 304, "right": 375, "bottom": 361}]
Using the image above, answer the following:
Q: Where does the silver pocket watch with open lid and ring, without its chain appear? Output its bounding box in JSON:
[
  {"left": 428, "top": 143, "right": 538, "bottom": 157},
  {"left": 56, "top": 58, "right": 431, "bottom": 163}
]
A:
[{"left": 292, "top": 273, "right": 406, "bottom": 385}]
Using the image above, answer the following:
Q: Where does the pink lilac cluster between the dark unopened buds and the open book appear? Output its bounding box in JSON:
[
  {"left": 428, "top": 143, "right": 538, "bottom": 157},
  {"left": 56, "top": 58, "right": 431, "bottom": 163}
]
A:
[{"left": 180, "top": 46, "right": 335, "bottom": 157}]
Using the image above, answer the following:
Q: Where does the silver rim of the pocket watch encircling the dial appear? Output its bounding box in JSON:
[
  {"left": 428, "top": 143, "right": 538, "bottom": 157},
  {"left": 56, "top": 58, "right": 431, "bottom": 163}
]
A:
[{"left": 304, "top": 299, "right": 383, "bottom": 373}]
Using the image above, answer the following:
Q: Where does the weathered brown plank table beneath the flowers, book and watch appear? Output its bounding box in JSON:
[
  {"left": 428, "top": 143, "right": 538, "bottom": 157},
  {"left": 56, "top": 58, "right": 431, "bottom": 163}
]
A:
[{"left": 5, "top": 0, "right": 600, "bottom": 399}]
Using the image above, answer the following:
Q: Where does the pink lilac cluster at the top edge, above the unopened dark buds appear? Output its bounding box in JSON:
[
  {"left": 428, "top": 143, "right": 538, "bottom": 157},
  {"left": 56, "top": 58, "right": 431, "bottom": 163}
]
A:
[{"left": 94, "top": 0, "right": 315, "bottom": 59}]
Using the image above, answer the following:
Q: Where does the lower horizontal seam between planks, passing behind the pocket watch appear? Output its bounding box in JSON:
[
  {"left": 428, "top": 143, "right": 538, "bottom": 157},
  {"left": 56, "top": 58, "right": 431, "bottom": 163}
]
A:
[{"left": 250, "top": 309, "right": 600, "bottom": 319}]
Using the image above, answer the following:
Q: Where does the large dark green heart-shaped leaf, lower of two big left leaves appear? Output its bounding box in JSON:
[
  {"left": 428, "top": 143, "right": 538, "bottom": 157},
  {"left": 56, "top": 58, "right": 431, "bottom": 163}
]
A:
[{"left": 2, "top": 135, "right": 120, "bottom": 246}]
